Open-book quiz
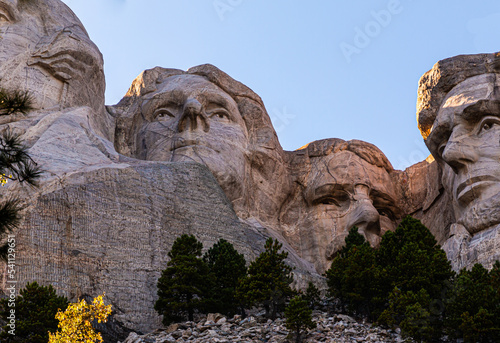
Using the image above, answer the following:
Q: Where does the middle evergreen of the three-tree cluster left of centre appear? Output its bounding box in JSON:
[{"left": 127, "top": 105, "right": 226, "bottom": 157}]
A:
[{"left": 203, "top": 239, "right": 247, "bottom": 315}]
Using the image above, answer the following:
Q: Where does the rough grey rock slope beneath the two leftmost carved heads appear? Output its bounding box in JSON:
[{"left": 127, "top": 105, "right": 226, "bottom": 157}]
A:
[{"left": 0, "top": 107, "right": 321, "bottom": 338}]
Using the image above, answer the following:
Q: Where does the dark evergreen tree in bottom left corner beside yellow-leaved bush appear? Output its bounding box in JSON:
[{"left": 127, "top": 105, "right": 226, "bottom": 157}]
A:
[{"left": 0, "top": 281, "right": 68, "bottom": 343}]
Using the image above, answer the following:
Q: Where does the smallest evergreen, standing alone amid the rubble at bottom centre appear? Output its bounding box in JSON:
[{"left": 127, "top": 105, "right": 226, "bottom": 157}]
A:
[{"left": 285, "top": 296, "right": 316, "bottom": 343}]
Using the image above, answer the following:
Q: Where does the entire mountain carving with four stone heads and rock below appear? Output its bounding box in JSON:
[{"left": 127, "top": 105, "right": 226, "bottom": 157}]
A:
[{"left": 0, "top": 0, "right": 500, "bottom": 331}]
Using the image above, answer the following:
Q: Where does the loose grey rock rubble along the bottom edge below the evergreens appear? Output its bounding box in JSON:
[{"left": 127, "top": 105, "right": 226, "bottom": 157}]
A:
[{"left": 117, "top": 311, "right": 413, "bottom": 343}]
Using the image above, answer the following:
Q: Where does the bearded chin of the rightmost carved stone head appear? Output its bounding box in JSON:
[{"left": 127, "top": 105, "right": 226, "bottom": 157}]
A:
[{"left": 458, "top": 193, "right": 500, "bottom": 234}]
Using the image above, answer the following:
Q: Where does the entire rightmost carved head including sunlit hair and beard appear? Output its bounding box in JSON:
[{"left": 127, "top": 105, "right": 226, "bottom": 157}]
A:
[{"left": 417, "top": 54, "right": 500, "bottom": 270}]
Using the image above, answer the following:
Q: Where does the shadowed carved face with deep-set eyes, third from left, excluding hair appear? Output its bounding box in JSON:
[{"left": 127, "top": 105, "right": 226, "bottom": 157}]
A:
[{"left": 283, "top": 151, "right": 398, "bottom": 272}]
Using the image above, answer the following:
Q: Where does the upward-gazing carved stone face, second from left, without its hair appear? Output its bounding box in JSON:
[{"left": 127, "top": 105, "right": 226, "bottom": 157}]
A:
[{"left": 136, "top": 74, "right": 248, "bottom": 200}]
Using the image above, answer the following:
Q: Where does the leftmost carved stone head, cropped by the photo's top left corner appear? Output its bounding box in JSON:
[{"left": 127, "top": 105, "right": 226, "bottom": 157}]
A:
[{"left": 0, "top": 0, "right": 104, "bottom": 109}]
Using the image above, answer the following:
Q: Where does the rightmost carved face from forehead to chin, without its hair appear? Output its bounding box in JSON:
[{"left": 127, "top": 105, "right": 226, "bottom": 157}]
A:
[{"left": 427, "top": 74, "right": 500, "bottom": 234}]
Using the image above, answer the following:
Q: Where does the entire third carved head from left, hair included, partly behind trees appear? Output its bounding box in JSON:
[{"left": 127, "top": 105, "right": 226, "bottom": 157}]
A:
[{"left": 279, "top": 139, "right": 401, "bottom": 273}]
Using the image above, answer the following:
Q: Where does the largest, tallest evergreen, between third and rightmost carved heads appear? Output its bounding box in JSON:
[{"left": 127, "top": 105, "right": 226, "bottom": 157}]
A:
[{"left": 377, "top": 216, "right": 454, "bottom": 341}]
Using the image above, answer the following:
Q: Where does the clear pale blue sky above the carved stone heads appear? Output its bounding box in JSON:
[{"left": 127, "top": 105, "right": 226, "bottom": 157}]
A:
[{"left": 60, "top": 0, "right": 500, "bottom": 169}]
